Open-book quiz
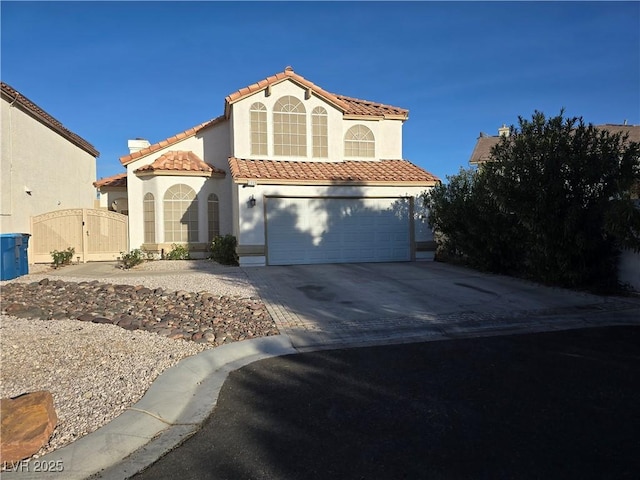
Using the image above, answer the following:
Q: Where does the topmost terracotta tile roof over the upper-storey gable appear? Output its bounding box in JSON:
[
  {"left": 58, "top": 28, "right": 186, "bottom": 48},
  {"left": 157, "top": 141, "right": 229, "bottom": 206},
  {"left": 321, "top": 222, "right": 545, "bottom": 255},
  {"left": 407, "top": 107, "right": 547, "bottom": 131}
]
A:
[{"left": 225, "top": 67, "right": 409, "bottom": 120}]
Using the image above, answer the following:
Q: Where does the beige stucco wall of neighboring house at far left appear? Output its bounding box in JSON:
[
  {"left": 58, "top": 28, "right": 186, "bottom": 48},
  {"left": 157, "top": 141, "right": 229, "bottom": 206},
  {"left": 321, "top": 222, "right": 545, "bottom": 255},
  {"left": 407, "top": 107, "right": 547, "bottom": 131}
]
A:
[{"left": 0, "top": 94, "right": 96, "bottom": 233}]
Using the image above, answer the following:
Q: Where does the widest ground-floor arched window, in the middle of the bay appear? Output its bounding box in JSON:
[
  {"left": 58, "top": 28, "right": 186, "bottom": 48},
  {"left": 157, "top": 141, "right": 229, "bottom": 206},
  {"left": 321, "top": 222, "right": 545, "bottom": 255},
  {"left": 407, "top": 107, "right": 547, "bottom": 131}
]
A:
[{"left": 164, "top": 184, "right": 198, "bottom": 242}]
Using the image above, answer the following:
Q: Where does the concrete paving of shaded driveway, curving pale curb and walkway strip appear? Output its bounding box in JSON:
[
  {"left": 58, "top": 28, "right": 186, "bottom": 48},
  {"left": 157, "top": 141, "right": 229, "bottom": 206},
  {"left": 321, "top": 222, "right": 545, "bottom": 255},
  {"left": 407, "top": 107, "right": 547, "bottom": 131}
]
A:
[{"left": 2, "top": 262, "right": 640, "bottom": 479}]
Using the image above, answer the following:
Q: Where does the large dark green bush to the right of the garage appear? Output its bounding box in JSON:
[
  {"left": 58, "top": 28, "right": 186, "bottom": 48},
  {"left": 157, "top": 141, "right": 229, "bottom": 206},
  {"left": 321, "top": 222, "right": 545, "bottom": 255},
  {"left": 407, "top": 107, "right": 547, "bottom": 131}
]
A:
[{"left": 427, "top": 111, "right": 640, "bottom": 288}]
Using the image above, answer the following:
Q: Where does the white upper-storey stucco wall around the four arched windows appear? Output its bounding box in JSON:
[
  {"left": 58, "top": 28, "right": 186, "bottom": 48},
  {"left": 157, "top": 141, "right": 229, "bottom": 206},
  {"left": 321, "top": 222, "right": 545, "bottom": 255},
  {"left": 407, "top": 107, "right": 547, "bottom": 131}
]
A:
[{"left": 231, "top": 81, "right": 402, "bottom": 162}]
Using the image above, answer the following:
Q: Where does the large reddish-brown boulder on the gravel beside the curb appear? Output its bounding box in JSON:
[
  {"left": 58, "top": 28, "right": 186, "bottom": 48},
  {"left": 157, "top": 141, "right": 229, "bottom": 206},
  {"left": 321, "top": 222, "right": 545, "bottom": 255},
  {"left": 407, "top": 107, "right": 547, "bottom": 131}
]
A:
[{"left": 0, "top": 390, "right": 58, "bottom": 463}]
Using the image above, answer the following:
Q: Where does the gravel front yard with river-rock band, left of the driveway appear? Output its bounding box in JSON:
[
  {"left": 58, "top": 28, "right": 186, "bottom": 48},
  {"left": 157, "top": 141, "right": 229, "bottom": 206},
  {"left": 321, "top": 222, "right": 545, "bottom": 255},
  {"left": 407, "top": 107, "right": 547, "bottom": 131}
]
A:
[{"left": 0, "top": 260, "right": 278, "bottom": 464}]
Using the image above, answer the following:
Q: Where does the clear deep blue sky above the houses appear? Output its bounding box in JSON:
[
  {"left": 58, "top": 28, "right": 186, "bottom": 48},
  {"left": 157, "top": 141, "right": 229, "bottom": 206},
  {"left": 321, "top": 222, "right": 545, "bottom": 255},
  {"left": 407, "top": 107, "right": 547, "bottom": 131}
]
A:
[{"left": 0, "top": 0, "right": 640, "bottom": 180}]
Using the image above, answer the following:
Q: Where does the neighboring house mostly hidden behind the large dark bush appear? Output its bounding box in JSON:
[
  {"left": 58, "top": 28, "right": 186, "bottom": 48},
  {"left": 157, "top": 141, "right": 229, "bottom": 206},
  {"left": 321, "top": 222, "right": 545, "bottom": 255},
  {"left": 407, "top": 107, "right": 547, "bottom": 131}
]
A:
[{"left": 469, "top": 122, "right": 640, "bottom": 291}]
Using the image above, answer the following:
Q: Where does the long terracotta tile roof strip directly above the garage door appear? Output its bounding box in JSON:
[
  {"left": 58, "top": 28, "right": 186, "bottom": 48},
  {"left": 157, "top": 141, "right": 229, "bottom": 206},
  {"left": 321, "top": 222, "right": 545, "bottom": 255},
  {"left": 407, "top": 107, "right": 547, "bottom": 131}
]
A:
[{"left": 229, "top": 157, "right": 439, "bottom": 186}]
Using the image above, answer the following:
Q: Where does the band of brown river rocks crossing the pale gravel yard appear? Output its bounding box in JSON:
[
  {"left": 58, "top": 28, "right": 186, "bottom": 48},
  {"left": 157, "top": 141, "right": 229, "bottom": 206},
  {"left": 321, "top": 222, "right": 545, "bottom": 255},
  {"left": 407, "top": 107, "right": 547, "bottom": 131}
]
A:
[{"left": 2, "top": 280, "right": 278, "bottom": 345}]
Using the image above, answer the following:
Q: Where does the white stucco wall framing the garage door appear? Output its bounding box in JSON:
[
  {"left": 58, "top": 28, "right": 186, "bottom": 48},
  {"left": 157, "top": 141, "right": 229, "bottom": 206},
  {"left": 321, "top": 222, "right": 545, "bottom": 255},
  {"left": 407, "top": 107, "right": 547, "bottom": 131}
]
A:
[{"left": 233, "top": 185, "right": 433, "bottom": 266}]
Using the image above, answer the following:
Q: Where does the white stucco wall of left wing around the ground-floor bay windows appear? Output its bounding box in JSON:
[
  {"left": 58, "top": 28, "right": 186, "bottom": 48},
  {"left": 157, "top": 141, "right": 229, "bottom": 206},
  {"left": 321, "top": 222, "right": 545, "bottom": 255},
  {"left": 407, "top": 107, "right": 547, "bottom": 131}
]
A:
[{"left": 127, "top": 122, "right": 233, "bottom": 249}]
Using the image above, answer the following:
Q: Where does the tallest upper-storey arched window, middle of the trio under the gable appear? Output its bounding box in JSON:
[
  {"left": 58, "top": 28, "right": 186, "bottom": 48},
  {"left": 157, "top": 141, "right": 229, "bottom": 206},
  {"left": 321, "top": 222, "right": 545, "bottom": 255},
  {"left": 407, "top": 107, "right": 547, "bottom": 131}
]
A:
[{"left": 273, "top": 95, "right": 307, "bottom": 157}]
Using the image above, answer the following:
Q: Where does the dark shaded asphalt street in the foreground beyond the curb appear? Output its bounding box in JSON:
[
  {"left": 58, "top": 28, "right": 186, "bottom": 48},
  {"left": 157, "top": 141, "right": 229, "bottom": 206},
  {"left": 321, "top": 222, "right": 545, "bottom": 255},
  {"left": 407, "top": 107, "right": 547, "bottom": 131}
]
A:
[{"left": 134, "top": 327, "right": 640, "bottom": 480}]
